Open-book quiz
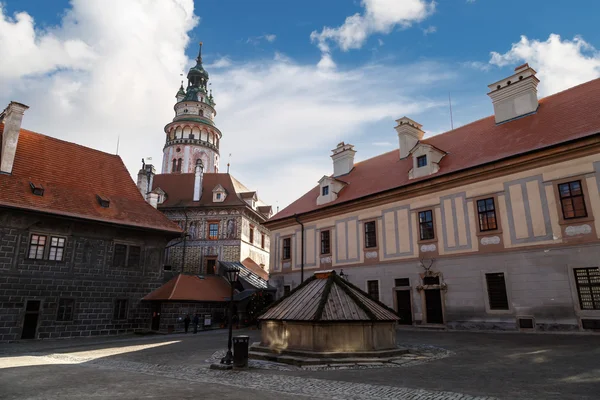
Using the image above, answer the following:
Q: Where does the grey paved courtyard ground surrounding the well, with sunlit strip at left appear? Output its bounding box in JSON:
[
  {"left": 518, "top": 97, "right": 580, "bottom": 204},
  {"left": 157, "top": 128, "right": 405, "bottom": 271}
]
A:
[{"left": 0, "top": 330, "right": 600, "bottom": 400}]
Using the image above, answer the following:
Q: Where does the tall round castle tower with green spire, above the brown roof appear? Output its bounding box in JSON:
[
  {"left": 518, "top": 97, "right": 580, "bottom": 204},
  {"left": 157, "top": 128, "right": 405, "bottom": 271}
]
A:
[{"left": 162, "top": 43, "right": 222, "bottom": 174}]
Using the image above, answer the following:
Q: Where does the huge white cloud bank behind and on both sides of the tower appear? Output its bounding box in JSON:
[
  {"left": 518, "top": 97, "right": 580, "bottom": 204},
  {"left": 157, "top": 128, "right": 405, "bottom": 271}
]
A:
[{"left": 0, "top": 0, "right": 453, "bottom": 208}]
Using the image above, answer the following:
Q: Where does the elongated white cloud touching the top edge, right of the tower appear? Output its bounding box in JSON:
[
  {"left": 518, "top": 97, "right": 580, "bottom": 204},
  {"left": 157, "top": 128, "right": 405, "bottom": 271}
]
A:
[{"left": 310, "top": 0, "right": 435, "bottom": 63}]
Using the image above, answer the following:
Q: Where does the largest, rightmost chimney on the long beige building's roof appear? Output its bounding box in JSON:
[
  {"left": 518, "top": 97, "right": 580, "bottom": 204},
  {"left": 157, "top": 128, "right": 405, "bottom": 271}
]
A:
[{"left": 488, "top": 64, "right": 540, "bottom": 124}]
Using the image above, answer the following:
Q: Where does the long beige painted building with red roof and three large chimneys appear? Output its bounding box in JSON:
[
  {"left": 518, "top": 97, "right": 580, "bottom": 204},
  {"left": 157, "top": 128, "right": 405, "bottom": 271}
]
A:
[{"left": 266, "top": 64, "right": 600, "bottom": 330}]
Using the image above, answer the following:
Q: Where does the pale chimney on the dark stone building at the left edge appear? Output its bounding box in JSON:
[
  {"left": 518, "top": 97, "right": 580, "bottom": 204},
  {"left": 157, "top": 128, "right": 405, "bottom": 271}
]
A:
[{"left": 0, "top": 101, "right": 29, "bottom": 174}]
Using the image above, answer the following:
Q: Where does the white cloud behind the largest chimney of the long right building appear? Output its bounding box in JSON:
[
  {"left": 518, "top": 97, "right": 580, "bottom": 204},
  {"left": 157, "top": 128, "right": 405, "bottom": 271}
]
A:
[{"left": 490, "top": 34, "right": 600, "bottom": 96}]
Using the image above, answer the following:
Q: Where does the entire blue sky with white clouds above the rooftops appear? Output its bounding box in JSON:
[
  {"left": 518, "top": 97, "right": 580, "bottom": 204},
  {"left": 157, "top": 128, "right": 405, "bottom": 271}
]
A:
[{"left": 0, "top": 0, "right": 600, "bottom": 210}]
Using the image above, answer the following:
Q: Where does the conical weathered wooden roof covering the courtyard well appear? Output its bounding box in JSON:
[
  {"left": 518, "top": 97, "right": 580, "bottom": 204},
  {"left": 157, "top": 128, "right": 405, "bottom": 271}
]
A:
[{"left": 259, "top": 271, "right": 399, "bottom": 322}]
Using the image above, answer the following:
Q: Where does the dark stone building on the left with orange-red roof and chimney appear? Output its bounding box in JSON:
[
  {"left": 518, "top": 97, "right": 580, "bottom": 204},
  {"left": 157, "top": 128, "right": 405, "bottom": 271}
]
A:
[{"left": 0, "top": 102, "right": 182, "bottom": 341}]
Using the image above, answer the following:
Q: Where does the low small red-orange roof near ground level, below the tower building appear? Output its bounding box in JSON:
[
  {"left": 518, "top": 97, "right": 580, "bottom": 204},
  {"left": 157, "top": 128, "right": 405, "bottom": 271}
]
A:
[{"left": 142, "top": 274, "right": 231, "bottom": 301}]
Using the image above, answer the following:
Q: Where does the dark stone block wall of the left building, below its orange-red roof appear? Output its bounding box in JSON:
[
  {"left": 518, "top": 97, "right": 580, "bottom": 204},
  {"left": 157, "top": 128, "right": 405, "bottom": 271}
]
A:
[{"left": 0, "top": 209, "right": 172, "bottom": 341}]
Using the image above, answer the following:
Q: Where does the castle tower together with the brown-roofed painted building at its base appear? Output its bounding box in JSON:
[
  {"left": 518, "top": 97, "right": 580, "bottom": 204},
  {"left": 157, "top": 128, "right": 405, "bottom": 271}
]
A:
[{"left": 138, "top": 44, "right": 272, "bottom": 275}]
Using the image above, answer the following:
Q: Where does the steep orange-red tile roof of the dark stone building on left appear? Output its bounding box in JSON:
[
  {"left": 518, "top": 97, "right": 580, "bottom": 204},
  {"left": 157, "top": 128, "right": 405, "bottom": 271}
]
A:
[{"left": 0, "top": 128, "right": 181, "bottom": 234}]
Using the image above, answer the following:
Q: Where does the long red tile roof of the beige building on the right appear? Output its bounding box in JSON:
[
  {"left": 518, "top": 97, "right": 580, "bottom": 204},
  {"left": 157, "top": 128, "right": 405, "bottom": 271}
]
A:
[{"left": 269, "top": 79, "right": 600, "bottom": 222}]
